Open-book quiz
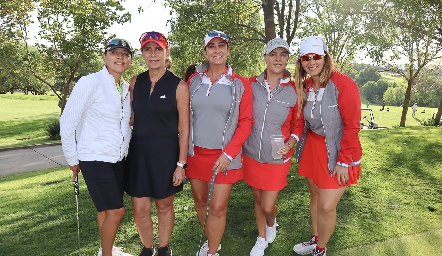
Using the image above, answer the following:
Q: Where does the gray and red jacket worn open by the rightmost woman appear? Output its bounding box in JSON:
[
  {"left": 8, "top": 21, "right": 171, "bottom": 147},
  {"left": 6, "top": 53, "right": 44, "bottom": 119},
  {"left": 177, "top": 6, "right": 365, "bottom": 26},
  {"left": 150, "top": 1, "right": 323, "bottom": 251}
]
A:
[{"left": 296, "top": 71, "right": 362, "bottom": 173}]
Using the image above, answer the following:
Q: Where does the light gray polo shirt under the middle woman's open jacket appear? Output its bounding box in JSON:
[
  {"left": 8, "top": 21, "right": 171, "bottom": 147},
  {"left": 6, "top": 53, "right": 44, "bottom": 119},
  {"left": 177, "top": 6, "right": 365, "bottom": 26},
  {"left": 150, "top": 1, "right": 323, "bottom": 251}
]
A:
[{"left": 191, "top": 75, "right": 232, "bottom": 149}]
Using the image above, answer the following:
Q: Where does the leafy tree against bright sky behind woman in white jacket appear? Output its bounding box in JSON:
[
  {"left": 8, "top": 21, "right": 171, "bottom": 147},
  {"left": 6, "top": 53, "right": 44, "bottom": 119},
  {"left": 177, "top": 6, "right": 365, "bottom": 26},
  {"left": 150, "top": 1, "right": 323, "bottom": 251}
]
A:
[{"left": 24, "top": 0, "right": 130, "bottom": 111}]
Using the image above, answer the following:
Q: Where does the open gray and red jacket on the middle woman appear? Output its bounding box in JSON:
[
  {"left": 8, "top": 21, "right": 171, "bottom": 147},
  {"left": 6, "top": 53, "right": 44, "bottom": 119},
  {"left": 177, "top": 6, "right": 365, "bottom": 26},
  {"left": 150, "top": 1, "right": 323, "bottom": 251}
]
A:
[{"left": 188, "top": 64, "right": 253, "bottom": 170}]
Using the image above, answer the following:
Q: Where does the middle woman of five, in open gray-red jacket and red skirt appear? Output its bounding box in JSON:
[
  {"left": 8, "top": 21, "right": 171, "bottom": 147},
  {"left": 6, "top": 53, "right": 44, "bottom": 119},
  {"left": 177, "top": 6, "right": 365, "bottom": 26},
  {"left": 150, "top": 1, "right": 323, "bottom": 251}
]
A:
[{"left": 186, "top": 31, "right": 253, "bottom": 256}]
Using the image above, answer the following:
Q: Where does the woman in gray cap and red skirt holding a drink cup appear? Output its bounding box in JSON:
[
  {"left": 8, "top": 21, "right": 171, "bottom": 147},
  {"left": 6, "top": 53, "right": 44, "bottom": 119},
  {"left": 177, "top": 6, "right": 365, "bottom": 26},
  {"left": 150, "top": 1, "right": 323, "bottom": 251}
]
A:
[{"left": 243, "top": 38, "right": 304, "bottom": 256}]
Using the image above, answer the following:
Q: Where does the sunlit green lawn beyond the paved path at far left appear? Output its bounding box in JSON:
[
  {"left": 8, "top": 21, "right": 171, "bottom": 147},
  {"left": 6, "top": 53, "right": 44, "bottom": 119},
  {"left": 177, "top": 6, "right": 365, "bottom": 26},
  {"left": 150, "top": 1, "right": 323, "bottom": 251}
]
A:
[{"left": 0, "top": 93, "right": 60, "bottom": 148}]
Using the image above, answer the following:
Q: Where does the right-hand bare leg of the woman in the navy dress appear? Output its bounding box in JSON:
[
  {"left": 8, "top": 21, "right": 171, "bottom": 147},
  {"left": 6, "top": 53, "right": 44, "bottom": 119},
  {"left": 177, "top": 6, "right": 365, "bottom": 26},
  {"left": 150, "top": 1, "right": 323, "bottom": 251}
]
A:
[{"left": 155, "top": 196, "right": 175, "bottom": 247}]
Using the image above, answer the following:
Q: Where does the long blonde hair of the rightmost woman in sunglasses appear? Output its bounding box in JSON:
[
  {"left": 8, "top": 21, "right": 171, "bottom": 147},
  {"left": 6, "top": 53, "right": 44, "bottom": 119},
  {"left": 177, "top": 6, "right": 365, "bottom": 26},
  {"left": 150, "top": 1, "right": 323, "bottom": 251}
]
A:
[{"left": 295, "top": 52, "right": 335, "bottom": 117}]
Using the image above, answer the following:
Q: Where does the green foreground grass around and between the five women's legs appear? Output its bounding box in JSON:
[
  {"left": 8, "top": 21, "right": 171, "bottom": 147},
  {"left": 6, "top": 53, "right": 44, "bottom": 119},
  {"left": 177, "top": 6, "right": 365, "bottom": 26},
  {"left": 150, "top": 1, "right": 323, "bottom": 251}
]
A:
[{"left": 0, "top": 126, "right": 442, "bottom": 256}]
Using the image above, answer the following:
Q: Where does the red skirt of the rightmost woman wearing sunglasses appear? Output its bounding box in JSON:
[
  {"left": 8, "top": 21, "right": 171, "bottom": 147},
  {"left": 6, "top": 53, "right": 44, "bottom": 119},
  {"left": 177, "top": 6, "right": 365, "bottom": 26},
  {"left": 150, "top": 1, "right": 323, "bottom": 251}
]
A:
[{"left": 298, "top": 130, "right": 361, "bottom": 189}]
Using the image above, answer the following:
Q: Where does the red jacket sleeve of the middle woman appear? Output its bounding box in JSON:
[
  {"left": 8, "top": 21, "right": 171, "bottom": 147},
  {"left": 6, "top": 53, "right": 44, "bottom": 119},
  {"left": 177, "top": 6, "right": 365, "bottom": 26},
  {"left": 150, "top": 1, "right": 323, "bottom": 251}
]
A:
[{"left": 224, "top": 76, "right": 253, "bottom": 158}]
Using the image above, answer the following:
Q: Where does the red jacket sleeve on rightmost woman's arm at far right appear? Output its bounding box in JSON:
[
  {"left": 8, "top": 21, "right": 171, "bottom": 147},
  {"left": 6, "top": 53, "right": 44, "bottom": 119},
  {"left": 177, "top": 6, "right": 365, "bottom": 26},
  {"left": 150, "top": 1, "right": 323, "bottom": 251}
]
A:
[{"left": 332, "top": 73, "right": 361, "bottom": 164}]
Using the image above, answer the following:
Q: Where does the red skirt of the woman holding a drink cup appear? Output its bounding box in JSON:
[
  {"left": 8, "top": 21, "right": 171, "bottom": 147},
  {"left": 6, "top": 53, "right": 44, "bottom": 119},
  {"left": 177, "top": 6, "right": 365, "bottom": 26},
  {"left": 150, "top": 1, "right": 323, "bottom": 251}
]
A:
[{"left": 243, "top": 155, "right": 292, "bottom": 191}]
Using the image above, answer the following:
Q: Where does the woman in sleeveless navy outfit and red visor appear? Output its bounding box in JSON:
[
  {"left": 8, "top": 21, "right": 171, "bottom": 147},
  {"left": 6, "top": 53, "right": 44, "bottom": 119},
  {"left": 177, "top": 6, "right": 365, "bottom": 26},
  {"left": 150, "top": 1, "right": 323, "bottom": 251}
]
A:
[{"left": 125, "top": 32, "right": 189, "bottom": 256}]
